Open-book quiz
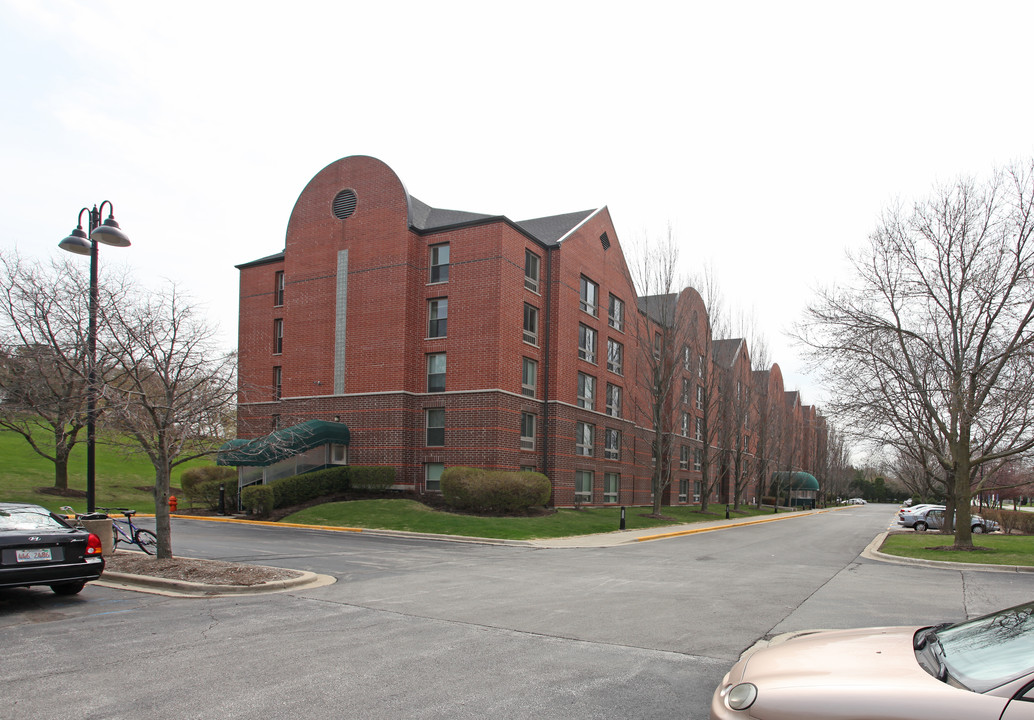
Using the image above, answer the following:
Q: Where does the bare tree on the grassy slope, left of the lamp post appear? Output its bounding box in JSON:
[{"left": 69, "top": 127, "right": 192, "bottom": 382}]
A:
[{"left": 0, "top": 253, "right": 124, "bottom": 490}]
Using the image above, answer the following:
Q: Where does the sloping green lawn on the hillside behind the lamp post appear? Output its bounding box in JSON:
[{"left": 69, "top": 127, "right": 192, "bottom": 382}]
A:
[{"left": 0, "top": 431, "right": 215, "bottom": 513}]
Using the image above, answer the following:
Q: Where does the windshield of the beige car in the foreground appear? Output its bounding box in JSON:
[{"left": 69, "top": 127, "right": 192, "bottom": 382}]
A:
[{"left": 936, "top": 602, "right": 1034, "bottom": 692}]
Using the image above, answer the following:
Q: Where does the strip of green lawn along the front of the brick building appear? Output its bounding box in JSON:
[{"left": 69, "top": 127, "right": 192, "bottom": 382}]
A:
[{"left": 283, "top": 500, "right": 771, "bottom": 540}]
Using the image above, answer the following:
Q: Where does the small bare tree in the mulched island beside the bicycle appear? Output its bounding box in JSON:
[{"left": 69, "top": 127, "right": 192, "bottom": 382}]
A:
[{"left": 104, "top": 287, "right": 237, "bottom": 558}]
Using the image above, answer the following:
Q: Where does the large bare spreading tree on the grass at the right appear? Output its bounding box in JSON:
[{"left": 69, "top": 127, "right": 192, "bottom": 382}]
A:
[{"left": 797, "top": 162, "right": 1034, "bottom": 549}]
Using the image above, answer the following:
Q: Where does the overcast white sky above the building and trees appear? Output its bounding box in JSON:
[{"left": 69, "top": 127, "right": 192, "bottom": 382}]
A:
[{"left": 0, "top": 0, "right": 1034, "bottom": 404}]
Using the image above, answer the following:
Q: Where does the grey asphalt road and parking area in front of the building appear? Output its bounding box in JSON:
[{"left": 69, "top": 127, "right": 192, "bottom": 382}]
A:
[{"left": 0, "top": 505, "right": 1034, "bottom": 719}]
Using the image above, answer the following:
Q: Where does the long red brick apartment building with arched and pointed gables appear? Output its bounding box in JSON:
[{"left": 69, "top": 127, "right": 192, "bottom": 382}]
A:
[{"left": 230, "top": 156, "right": 824, "bottom": 506}]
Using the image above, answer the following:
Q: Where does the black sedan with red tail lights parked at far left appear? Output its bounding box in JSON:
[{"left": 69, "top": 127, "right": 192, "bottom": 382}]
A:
[{"left": 0, "top": 503, "right": 104, "bottom": 595}]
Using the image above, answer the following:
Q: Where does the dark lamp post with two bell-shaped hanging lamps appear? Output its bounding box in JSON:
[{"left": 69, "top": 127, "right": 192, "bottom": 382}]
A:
[{"left": 58, "top": 200, "right": 129, "bottom": 512}]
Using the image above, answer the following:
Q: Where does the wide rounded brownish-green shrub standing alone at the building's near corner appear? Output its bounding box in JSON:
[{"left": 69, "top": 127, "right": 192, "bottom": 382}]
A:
[{"left": 442, "top": 468, "right": 552, "bottom": 514}]
